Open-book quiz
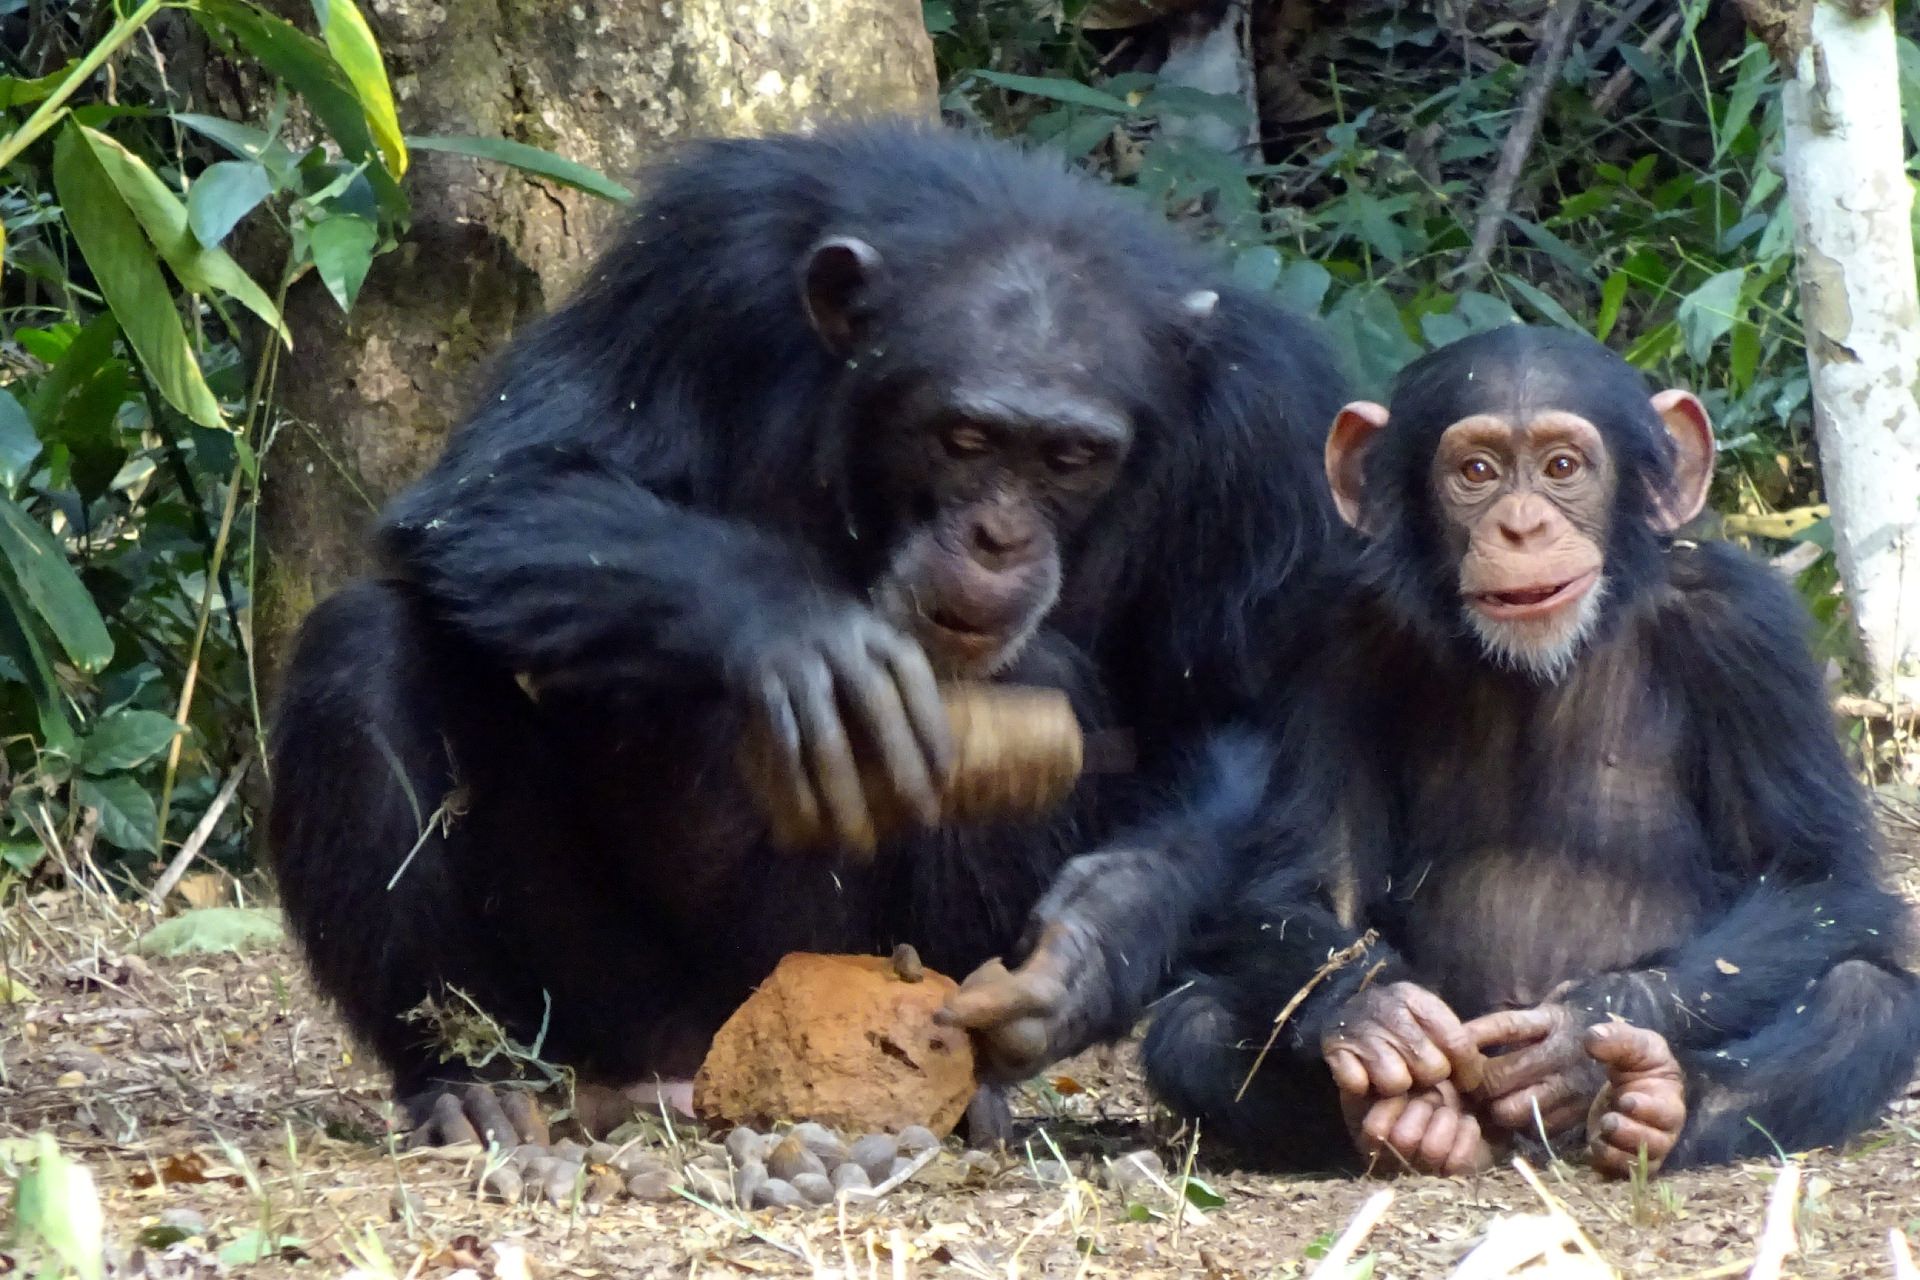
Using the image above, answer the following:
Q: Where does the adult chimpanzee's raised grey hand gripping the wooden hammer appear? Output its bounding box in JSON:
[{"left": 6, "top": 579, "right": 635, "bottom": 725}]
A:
[{"left": 728, "top": 601, "right": 952, "bottom": 852}]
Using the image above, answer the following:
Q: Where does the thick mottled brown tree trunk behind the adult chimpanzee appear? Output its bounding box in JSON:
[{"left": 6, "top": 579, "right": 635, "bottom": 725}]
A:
[{"left": 253, "top": 0, "right": 937, "bottom": 695}]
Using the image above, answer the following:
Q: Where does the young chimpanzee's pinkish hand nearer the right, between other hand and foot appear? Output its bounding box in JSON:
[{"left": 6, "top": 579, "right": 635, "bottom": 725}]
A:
[{"left": 1467, "top": 1004, "right": 1605, "bottom": 1136}]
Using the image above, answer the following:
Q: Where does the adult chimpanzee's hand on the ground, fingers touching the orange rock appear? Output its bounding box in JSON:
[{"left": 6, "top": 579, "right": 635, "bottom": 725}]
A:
[{"left": 933, "top": 923, "right": 1106, "bottom": 1082}]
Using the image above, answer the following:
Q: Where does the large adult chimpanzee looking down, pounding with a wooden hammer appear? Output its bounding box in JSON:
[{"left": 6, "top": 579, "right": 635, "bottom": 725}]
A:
[{"left": 271, "top": 127, "right": 1342, "bottom": 1140}]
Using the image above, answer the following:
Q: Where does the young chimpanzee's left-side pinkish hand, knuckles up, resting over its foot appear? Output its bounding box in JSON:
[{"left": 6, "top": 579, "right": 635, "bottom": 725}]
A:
[{"left": 1321, "top": 983, "right": 1484, "bottom": 1098}]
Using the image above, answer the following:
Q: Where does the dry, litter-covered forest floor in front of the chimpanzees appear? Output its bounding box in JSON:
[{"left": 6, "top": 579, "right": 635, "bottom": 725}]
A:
[{"left": 0, "top": 809, "right": 1920, "bottom": 1280}]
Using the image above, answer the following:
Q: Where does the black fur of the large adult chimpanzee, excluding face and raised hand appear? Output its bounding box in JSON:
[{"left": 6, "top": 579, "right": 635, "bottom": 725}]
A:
[{"left": 271, "top": 127, "right": 1340, "bottom": 1094}]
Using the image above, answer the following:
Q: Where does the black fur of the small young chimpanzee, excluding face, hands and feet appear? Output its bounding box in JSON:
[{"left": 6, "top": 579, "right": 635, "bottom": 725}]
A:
[{"left": 1146, "top": 328, "right": 1920, "bottom": 1167}]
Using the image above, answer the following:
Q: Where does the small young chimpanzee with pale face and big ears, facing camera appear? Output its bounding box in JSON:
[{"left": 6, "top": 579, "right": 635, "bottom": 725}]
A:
[{"left": 1146, "top": 326, "right": 1920, "bottom": 1174}]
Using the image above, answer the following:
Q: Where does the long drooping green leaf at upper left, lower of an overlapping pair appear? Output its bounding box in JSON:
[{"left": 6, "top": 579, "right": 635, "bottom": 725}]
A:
[{"left": 54, "top": 123, "right": 221, "bottom": 426}]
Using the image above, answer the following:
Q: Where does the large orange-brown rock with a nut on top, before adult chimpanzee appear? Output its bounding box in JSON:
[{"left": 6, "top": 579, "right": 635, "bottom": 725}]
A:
[{"left": 693, "top": 952, "right": 977, "bottom": 1143}]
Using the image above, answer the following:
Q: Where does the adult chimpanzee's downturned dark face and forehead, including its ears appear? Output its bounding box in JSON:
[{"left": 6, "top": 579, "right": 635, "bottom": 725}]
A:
[{"left": 806, "top": 242, "right": 1212, "bottom": 676}]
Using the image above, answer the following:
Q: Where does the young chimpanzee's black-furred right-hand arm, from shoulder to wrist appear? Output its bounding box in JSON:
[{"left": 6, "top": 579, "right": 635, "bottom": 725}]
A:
[{"left": 1571, "top": 545, "right": 1905, "bottom": 1048}]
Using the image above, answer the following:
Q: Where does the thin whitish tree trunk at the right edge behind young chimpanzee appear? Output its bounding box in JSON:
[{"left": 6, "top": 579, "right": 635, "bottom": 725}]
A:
[{"left": 1784, "top": 0, "right": 1920, "bottom": 697}]
